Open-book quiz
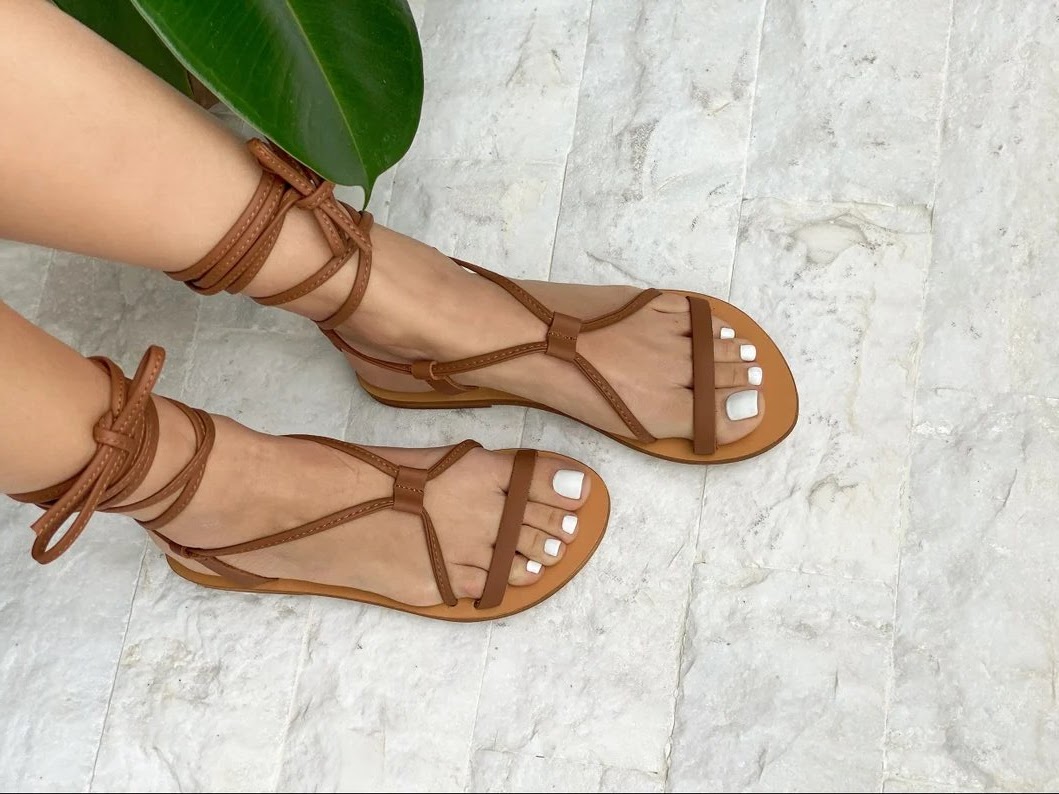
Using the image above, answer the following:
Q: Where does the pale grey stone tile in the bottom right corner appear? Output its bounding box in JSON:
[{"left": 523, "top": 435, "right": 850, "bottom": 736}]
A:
[{"left": 887, "top": 389, "right": 1059, "bottom": 791}]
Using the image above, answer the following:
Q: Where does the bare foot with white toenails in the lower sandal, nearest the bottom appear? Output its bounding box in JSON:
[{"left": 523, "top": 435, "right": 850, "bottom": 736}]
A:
[{"left": 123, "top": 398, "right": 589, "bottom": 607}]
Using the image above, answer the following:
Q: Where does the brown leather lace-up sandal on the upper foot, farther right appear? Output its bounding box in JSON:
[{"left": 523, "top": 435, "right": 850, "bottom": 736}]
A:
[{"left": 170, "top": 140, "right": 798, "bottom": 464}]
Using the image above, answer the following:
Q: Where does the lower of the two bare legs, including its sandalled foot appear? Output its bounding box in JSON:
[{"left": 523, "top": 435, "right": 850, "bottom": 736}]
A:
[{"left": 0, "top": 303, "right": 589, "bottom": 606}]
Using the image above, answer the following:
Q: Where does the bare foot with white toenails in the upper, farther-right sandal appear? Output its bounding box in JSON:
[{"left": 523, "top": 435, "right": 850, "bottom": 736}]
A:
[{"left": 326, "top": 227, "right": 768, "bottom": 444}]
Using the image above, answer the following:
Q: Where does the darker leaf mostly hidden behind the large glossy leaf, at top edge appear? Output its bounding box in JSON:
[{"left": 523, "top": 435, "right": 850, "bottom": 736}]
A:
[{"left": 55, "top": 0, "right": 192, "bottom": 96}]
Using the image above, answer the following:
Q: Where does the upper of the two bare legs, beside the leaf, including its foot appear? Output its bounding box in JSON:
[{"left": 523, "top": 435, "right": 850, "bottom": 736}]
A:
[{"left": 0, "top": 0, "right": 769, "bottom": 457}]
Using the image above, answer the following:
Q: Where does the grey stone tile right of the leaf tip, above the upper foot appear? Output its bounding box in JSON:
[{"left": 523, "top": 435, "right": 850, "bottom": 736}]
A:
[{"left": 390, "top": 161, "right": 562, "bottom": 278}]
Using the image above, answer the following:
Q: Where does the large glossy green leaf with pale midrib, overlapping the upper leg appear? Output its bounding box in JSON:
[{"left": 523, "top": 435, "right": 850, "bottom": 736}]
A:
[{"left": 124, "top": 0, "right": 423, "bottom": 190}]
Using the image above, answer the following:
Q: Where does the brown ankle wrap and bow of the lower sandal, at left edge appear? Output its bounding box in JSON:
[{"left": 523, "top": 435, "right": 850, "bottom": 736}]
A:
[{"left": 12, "top": 345, "right": 214, "bottom": 564}]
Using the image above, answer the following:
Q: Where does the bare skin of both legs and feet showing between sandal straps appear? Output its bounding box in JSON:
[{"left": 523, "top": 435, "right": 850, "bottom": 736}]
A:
[{"left": 0, "top": 0, "right": 768, "bottom": 603}]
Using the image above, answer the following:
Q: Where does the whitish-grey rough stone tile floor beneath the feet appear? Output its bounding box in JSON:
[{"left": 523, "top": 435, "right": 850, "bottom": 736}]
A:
[{"left": 0, "top": 0, "right": 1059, "bottom": 792}]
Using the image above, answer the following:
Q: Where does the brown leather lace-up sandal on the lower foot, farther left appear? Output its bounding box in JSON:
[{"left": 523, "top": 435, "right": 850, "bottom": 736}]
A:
[{"left": 13, "top": 346, "right": 610, "bottom": 621}]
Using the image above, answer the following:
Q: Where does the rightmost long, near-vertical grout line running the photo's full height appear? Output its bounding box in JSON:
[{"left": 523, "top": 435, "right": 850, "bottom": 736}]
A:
[{"left": 879, "top": 0, "right": 956, "bottom": 792}]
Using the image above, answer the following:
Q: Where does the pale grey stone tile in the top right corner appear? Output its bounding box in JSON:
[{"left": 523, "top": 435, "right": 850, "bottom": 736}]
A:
[{"left": 922, "top": 0, "right": 1059, "bottom": 397}]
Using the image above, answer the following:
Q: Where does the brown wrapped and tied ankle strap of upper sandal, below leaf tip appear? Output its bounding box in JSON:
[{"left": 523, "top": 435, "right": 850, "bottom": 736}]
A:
[{"left": 168, "top": 139, "right": 374, "bottom": 332}]
